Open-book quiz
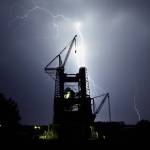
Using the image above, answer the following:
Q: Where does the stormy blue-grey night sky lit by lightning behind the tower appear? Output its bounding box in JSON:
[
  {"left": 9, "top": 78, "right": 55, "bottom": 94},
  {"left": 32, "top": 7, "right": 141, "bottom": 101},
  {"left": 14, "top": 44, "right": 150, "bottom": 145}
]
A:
[{"left": 0, "top": 0, "right": 150, "bottom": 124}]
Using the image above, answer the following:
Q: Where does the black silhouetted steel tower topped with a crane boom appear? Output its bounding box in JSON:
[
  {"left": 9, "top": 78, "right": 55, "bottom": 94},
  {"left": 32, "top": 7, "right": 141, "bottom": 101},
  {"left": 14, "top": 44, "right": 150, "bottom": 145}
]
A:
[{"left": 45, "top": 35, "right": 108, "bottom": 139}]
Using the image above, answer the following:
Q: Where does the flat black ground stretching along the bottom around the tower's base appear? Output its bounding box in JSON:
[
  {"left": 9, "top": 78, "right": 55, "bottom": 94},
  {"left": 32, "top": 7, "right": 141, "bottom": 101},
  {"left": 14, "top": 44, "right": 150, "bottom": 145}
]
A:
[{"left": 0, "top": 120, "right": 150, "bottom": 147}]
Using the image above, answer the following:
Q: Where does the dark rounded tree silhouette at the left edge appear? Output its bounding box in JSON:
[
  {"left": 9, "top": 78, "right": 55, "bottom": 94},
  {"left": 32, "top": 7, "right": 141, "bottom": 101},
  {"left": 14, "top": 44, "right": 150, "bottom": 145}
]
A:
[{"left": 0, "top": 93, "right": 20, "bottom": 128}]
